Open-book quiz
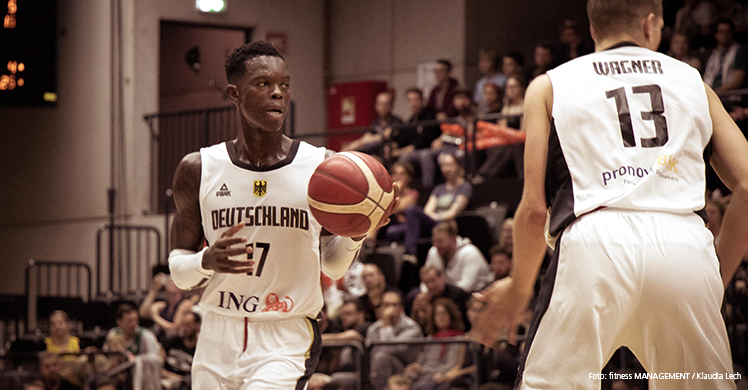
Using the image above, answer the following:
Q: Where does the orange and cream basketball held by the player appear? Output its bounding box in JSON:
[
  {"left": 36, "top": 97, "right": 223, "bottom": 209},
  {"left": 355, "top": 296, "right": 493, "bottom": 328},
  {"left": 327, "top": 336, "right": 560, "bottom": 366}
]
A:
[{"left": 307, "top": 152, "right": 395, "bottom": 237}]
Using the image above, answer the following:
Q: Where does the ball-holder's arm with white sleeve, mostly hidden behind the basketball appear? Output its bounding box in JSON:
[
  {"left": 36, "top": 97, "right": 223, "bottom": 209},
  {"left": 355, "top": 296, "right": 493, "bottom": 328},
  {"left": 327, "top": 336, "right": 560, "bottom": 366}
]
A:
[{"left": 320, "top": 149, "right": 400, "bottom": 280}]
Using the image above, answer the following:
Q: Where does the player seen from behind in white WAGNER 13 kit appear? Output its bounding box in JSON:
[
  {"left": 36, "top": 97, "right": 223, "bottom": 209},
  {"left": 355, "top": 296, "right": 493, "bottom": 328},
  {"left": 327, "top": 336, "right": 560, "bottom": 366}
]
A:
[{"left": 473, "top": 0, "right": 748, "bottom": 390}]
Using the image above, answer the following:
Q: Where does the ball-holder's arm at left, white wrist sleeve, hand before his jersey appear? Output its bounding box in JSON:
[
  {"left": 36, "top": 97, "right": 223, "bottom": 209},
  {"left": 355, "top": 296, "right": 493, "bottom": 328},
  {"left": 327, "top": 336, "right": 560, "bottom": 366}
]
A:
[{"left": 169, "top": 152, "right": 254, "bottom": 290}]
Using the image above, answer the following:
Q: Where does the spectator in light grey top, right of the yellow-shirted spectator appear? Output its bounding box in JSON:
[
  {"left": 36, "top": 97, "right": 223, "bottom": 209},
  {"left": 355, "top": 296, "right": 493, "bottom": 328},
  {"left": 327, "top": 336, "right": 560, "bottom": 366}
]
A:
[{"left": 107, "top": 303, "right": 163, "bottom": 390}]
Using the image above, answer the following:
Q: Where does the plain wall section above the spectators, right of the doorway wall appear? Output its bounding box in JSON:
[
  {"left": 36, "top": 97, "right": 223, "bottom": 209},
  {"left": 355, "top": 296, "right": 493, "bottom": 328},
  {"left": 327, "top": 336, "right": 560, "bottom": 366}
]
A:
[{"left": 329, "top": 0, "right": 465, "bottom": 119}]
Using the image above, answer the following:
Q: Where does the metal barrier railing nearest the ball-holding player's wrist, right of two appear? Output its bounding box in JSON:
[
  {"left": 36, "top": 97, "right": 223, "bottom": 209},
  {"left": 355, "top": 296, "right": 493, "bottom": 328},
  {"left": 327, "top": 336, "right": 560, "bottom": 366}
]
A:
[{"left": 96, "top": 225, "right": 164, "bottom": 298}]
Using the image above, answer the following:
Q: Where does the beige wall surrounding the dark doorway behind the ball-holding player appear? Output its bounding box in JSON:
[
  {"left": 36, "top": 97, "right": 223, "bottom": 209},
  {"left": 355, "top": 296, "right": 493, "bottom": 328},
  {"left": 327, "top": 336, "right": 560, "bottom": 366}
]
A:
[{"left": 0, "top": 0, "right": 325, "bottom": 294}]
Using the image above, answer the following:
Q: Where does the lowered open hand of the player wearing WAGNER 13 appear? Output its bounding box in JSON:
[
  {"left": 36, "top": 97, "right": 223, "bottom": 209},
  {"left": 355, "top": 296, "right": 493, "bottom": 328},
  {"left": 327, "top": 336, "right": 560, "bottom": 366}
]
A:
[{"left": 470, "top": 278, "right": 532, "bottom": 348}]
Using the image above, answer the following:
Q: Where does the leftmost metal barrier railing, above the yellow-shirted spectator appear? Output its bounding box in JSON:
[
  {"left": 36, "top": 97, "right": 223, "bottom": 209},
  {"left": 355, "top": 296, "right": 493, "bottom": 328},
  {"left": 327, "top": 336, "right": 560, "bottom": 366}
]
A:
[{"left": 25, "top": 259, "right": 92, "bottom": 332}]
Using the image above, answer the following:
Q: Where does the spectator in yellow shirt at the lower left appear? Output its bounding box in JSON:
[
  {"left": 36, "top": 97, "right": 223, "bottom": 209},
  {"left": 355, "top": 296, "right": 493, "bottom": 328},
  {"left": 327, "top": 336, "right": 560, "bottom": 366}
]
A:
[{"left": 44, "top": 310, "right": 89, "bottom": 386}]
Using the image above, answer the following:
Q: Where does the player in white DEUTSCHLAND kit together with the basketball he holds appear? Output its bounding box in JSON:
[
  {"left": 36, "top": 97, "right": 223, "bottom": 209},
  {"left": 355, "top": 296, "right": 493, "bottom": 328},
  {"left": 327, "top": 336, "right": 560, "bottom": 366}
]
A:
[{"left": 169, "top": 42, "right": 399, "bottom": 390}]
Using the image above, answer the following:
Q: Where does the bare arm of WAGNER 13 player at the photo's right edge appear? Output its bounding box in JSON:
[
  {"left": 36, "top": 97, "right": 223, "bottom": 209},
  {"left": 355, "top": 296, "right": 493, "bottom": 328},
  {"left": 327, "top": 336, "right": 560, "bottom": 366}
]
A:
[{"left": 704, "top": 84, "right": 748, "bottom": 286}]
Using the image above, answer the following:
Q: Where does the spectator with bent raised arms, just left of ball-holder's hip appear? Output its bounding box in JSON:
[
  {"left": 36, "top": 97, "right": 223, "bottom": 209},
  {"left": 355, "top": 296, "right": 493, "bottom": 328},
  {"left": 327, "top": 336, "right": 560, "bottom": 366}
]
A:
[{"left": 139, "top": 273, "right": 195, "bottom": 341}]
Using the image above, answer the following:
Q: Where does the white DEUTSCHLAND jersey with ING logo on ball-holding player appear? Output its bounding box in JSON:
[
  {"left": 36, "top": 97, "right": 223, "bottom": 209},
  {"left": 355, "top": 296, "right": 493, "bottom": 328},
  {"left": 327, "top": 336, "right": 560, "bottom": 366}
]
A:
[{"left": 200, "top": 141, "right": 325, "bottom": 320}]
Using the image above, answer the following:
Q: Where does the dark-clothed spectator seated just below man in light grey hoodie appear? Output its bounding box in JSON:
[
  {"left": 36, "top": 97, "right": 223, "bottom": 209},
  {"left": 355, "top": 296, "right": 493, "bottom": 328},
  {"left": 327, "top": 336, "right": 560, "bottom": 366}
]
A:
[{"left": 405, "top": 265, "right": 470, "bottom": 334}]
